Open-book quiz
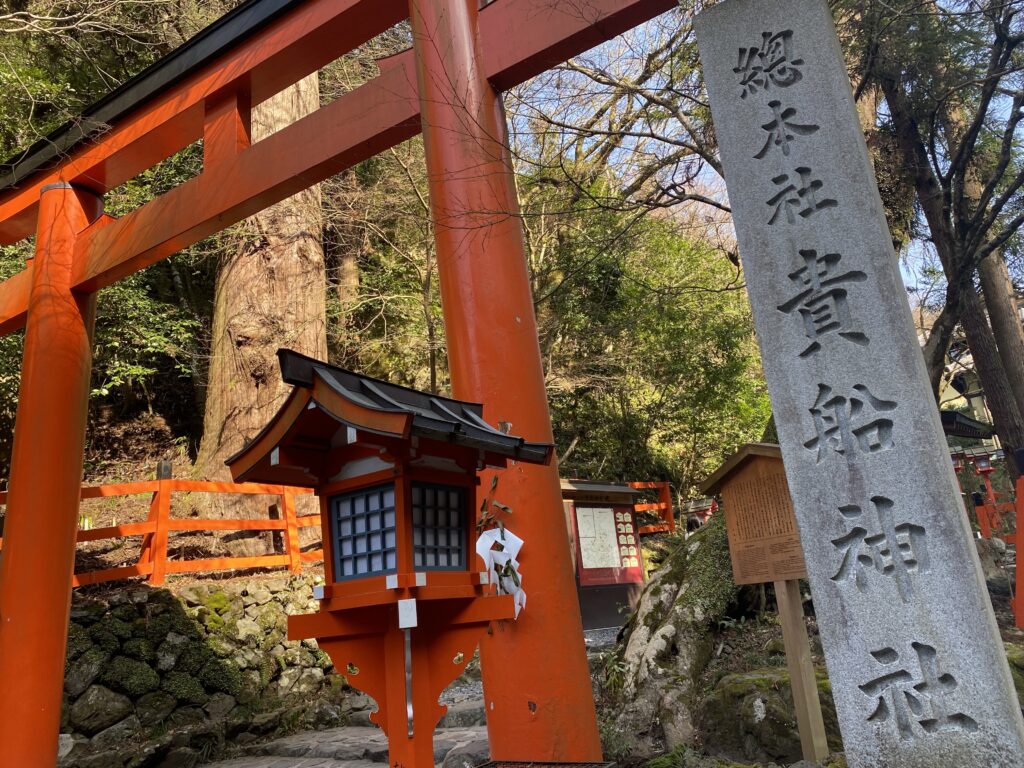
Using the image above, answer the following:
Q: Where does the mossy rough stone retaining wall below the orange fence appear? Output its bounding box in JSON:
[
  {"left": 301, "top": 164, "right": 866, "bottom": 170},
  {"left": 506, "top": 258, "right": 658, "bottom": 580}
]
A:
[{"left": 59, "top": 577, "right": 371, "bottom": 768}]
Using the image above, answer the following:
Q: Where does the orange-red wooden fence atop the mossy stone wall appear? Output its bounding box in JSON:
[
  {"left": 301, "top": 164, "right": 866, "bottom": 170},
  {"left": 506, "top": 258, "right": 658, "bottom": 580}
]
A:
[{"left": 0, "top": 479, "right": 324, "bottom": 587}]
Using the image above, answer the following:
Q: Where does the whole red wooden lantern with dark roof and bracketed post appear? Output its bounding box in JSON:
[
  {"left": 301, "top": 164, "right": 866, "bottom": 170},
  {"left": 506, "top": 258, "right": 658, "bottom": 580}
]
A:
[{"left": 228, "top": 350, "right": 553, "bottom": 768}]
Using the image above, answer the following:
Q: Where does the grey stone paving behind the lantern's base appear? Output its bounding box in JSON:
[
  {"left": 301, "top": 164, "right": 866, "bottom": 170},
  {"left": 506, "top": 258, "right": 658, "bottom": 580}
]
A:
[{"left": 202, "top": 726, "right": 487, "bottom": 768}]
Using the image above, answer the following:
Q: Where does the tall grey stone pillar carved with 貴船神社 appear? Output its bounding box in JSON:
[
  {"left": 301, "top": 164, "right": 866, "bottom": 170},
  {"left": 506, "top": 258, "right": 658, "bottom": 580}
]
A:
[{"left": 696, "top": 0, "right": 1024, "bottom": 768}]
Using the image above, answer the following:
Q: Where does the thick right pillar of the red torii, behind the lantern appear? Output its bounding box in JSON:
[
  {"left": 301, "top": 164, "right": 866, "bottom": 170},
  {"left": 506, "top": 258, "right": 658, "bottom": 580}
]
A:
[{"left": 410, "top": 0, "right": 601, "bottom": 762}]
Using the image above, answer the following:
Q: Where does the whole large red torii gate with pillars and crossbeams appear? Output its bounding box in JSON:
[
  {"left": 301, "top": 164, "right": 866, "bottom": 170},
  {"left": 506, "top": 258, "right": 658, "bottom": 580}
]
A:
[{"left": 0, "top": 0, "right": 675, "bottom": 766}]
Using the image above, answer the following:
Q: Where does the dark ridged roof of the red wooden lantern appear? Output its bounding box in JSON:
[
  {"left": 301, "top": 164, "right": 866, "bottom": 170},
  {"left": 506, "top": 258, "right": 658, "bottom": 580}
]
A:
[{"left": 240, "top": 349, "right": 554, "bottom": 464}]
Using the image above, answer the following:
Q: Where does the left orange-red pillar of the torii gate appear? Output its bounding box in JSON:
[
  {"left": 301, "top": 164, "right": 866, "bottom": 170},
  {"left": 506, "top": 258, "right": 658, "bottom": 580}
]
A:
[{"left": 0, "top": 183, "right": 102, "bottom": 768}]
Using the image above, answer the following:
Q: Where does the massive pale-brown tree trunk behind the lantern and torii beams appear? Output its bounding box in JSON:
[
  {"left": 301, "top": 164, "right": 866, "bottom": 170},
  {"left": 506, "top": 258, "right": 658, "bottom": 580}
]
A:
[{"left": 196, "top": 75, "right": 327, "bottom": 553}]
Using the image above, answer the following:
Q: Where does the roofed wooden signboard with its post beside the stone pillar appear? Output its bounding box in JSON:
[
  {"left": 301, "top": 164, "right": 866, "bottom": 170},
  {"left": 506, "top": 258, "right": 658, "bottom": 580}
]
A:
[{"left": 700, "top": 443, "right": 828, "bottom": 762}]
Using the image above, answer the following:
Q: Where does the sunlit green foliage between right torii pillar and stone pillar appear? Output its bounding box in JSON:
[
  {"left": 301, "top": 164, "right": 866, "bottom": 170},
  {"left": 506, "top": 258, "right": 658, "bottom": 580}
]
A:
[{"left": 527, "top": 180, "right": 770, "bottom": 490}]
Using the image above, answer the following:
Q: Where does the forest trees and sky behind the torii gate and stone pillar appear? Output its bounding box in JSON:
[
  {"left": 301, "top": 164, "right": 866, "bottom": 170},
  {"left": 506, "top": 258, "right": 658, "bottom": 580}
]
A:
[{"left": 0, "top": 0, "right": 1024, "bottom": 514}]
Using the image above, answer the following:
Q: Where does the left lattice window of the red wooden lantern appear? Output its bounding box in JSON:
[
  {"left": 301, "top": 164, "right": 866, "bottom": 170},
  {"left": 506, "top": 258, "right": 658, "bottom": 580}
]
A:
[{"left": 331, "top": 483, "right": 397, "bottom": 582}]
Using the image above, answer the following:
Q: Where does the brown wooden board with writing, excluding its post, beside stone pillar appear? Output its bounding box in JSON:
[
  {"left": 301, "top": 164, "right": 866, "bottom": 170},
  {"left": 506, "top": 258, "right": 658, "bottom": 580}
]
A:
[{"left": 719, "top": 445, "right": 807, "bottom": 584}]
